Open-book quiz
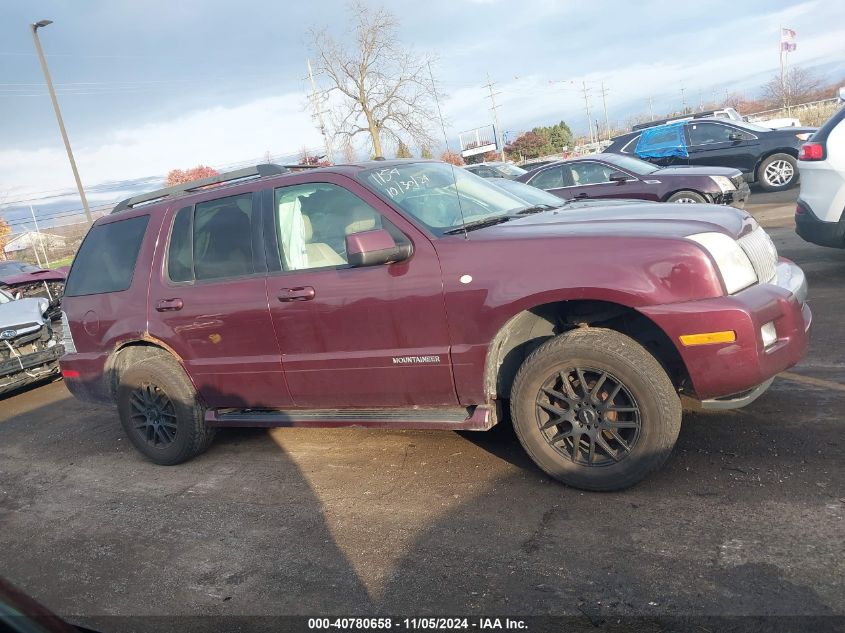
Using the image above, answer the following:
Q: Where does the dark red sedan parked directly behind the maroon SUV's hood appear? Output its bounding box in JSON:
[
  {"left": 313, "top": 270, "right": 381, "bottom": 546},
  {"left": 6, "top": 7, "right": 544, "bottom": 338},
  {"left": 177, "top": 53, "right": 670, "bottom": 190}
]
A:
[{"left": 517, "top": 154, "right": 750, "bottom": 209}]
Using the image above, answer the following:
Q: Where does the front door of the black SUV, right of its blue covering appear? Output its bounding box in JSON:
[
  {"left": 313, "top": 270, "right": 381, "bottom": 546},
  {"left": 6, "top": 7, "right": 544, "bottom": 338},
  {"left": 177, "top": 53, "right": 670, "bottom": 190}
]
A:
[{"left": 685, "top": 121, "right": 760, "bottom": 173}]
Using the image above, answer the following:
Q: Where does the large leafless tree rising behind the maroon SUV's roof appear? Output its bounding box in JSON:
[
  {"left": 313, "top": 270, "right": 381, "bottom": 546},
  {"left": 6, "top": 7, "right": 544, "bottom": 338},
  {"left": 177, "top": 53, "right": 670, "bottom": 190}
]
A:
[{"left": 311, "top": 3, "right": 434, "bottom": 156}]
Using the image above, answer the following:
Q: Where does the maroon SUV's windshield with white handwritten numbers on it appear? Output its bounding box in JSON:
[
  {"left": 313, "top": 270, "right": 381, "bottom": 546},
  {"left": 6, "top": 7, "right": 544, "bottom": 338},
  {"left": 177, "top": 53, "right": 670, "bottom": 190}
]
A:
[{"left": 358, "top": 162, "right": 526, "bottom": 236}]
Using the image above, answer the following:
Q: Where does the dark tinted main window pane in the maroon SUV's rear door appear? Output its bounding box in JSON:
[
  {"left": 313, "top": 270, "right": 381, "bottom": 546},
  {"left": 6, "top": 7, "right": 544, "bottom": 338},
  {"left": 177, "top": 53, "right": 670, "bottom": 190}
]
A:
[{"left": 194, "top": 193, "right": 255, "bottom": 280}]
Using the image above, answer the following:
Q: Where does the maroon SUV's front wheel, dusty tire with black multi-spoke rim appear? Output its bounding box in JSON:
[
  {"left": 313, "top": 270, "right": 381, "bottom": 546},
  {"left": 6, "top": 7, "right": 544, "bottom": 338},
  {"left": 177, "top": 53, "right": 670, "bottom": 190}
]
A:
[{"left": 511, "top": 328, "right": 681, "bottom": 490}]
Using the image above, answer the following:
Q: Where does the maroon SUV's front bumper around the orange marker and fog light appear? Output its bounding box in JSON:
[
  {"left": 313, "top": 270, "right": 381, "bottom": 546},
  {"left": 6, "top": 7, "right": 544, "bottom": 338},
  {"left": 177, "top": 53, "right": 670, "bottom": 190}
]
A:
[{"left": 640, "top": 259, "right": 812, "bottom": 408}]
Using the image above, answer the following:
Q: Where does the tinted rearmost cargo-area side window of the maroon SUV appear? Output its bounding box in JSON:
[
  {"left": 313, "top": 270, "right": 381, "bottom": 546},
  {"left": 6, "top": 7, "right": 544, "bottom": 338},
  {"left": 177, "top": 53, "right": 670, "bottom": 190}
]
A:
[{"left": 65, "top": 215, "right": 150, "bottom": 297}]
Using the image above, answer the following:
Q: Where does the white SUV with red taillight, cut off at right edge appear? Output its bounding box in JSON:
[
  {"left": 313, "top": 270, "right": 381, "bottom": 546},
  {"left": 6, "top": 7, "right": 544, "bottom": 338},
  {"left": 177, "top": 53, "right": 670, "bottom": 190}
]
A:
[{"left": 795, "top": 107, "right": 845, "bottom": 248}]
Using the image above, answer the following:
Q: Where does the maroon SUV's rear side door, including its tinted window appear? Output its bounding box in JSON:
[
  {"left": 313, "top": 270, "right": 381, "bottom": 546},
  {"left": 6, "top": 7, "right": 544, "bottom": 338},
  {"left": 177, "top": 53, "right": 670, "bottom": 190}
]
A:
[{"left": 149, "top": 185, "right": 292, "bottom": 408}]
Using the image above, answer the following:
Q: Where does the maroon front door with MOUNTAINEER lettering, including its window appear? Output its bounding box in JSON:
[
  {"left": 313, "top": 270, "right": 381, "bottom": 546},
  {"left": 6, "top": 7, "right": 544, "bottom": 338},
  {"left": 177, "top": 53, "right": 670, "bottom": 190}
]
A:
[{"left": 265, "top": 175, "right": 457, "bottom": 408}]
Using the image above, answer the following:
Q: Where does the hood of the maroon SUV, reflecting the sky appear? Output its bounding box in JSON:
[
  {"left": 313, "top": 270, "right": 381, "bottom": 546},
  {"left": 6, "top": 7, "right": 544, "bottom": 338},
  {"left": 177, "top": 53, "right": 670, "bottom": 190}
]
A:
[{"left": 469, "top": 201, "right": 756, "bottom": 239}]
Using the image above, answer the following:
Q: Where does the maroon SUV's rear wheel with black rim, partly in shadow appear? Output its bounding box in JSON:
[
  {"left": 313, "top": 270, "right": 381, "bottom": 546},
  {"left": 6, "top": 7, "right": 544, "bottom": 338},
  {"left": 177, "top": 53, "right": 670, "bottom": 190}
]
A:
[{"left": 117, "top": 355, "right": 216, "bottom": 466}]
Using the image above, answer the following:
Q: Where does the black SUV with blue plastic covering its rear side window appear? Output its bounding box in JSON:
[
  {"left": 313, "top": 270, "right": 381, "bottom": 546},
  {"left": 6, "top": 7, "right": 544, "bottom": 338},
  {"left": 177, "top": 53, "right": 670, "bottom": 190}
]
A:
[{"left": 604, "top": 119, "right": 816, "bottom": 191}]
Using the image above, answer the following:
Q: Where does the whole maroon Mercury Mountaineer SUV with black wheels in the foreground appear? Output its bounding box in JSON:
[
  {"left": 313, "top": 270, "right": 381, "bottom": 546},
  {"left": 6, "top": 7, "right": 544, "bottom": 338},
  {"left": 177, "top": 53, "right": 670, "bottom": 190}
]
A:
[{"left": 61, "top": 161, "right": 810, "bottom": 490}]
